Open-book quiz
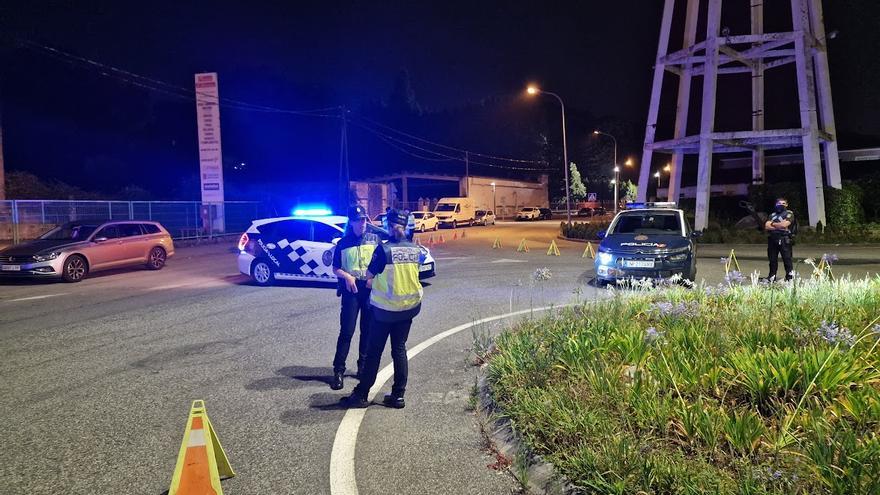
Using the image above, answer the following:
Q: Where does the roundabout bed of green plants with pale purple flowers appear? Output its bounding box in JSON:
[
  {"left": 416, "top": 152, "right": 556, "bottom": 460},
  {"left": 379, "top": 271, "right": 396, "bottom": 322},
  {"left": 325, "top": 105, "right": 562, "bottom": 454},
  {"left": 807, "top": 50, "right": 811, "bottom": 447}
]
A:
[{"left": 483, "top": 277, "right": 880, "bottom": 494}]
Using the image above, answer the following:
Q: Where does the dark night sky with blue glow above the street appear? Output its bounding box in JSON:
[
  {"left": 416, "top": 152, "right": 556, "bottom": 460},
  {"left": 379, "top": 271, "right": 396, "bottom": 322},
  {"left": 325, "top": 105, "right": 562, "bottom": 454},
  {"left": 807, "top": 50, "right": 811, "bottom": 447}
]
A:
[{"left": 0, "top": 0, "right": 880, "bottom": 199}]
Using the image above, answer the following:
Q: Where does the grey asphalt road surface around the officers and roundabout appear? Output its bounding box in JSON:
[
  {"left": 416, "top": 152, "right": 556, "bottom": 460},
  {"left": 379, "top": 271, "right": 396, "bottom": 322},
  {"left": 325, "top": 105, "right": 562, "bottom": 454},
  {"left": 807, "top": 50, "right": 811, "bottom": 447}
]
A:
[{"left": 0, "top": 221, "right": 880, "bottom": 495}]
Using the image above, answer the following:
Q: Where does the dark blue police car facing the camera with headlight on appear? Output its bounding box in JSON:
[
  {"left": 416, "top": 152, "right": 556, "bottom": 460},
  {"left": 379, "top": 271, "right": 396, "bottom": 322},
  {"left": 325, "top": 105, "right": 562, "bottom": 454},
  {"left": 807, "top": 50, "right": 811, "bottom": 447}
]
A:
[{"left": 596, "top": 203, "right": 702, "bottom": 284}]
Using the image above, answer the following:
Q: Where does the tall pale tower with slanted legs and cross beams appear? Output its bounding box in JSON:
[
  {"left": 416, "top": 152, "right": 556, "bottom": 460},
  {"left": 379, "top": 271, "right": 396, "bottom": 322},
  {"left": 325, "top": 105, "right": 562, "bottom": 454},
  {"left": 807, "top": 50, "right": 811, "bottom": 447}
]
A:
[{"left": 638, "top": 0, "right": 841, "bottom": 229}]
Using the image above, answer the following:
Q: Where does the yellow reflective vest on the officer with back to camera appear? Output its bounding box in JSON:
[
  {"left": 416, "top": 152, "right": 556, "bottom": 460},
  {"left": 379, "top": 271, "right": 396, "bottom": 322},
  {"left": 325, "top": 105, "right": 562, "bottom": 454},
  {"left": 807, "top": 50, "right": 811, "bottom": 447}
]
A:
[{"left": 370, "top": 242, "right": 422, "bottom": 312}]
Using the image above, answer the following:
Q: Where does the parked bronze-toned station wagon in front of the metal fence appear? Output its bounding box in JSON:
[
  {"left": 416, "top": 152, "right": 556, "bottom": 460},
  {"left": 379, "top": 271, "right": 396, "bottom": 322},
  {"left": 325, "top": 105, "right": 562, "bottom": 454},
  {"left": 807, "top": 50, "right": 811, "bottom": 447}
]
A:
[{"left": 0, "top": 221, "right": 174, "bottom": 282}]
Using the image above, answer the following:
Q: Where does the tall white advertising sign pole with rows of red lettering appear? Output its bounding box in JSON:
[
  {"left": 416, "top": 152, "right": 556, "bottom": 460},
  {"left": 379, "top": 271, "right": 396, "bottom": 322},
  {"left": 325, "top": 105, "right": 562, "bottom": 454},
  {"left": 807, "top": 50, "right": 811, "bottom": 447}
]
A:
[{"left": 195, "top": 72, "right": 226, "bottom": 235}]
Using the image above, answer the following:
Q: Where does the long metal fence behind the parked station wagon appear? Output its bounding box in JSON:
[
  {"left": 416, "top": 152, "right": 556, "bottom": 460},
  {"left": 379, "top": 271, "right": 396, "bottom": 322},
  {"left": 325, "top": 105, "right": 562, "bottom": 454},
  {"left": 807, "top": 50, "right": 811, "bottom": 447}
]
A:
[{"left": 0, "top": 200, "right": 271, "bottom": 242}]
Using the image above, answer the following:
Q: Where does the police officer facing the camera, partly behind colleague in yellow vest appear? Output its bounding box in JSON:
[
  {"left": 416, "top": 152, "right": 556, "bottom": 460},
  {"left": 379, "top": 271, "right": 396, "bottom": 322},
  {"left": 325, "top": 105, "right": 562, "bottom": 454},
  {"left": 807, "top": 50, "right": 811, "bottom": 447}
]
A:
[{"left": 330, "top": 206, "right": 379, "bottom": 390}]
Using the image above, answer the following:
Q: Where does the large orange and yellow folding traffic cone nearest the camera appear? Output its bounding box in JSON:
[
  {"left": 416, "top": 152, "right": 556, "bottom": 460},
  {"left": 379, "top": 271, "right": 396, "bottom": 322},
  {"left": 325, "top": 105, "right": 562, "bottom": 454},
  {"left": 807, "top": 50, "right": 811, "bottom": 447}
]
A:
[{"left": 168, "top": 400, "right": 235, "bottom": 495}]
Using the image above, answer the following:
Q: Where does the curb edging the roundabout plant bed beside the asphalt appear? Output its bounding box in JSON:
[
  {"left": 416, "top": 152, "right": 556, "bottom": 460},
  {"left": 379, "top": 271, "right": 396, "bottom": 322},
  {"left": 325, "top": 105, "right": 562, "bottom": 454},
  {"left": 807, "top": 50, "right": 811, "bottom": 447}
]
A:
[{"left": 476, "top": 364, "right": 577, "bottom": 495}]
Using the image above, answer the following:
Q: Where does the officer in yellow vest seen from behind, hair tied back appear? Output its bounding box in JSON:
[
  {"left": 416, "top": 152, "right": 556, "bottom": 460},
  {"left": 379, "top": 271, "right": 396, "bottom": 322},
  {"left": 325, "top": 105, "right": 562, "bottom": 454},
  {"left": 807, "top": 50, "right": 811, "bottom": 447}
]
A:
[{"left": 341, "top": 210, "right": 422, "bottom": 409}]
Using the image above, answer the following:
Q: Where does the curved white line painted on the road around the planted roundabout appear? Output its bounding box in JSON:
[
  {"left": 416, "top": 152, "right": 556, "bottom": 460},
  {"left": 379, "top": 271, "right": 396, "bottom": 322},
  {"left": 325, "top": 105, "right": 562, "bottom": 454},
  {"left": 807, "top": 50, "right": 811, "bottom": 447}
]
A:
[{"left": 330, "top": 306, "right": 562, "bottom": 495}]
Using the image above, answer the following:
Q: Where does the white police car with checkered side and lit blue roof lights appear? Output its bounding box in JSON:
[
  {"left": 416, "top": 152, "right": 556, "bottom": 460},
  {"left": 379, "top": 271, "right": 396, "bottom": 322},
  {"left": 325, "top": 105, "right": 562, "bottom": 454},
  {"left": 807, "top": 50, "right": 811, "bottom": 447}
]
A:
[{"left": 238, "top": 211, "right": 435, "bottom": 286}]
